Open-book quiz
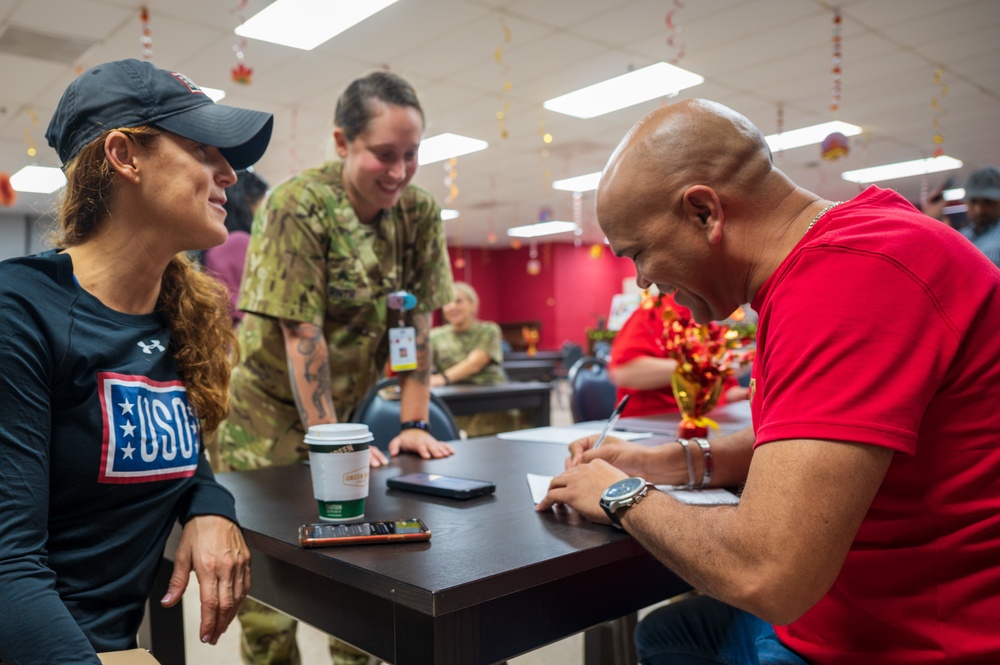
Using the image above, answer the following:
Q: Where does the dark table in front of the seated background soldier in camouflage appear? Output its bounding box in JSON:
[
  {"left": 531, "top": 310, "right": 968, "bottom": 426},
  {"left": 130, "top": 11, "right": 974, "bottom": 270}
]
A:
[{"left": 432, "top": 381, "right": 552, "bottom": 427}]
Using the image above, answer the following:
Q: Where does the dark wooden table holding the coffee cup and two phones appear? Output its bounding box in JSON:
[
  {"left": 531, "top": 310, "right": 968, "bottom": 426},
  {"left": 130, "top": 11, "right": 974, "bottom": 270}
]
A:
[{"left": 151, "top": 437, "right": 689, "bottom": 665}]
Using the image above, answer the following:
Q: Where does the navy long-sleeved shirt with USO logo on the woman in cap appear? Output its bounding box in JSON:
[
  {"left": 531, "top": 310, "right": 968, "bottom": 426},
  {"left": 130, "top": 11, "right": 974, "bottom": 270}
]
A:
[{"left": 0, "top": 251, "right": 235, "bottom": 663}]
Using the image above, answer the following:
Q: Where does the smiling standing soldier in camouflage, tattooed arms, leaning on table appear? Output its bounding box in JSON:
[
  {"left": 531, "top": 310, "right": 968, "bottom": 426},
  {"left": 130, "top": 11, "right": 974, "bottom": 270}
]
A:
[{"left": 220, "top": 72, "right": 453, "bottom": 665}]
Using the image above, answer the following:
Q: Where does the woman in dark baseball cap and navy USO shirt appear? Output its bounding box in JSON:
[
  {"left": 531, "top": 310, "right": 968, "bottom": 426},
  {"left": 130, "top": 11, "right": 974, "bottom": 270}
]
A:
[{"left": 0, "top": 60, "right": 273, "bottom": 665}]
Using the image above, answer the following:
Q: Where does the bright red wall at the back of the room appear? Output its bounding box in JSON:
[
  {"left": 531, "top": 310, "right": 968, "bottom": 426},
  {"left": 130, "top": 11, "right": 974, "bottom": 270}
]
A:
[{"left": 448, "top": 243, "right": 635, "bottom": 349}]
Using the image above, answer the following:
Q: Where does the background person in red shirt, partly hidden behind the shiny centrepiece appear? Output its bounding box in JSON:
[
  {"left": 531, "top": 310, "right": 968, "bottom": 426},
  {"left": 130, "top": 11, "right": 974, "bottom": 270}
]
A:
[{"left": 608, "top": 291, "right": 748, "bottom": 417}]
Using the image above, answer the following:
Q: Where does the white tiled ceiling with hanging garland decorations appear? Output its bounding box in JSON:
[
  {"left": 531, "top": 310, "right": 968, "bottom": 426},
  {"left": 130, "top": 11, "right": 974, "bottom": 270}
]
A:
[{"left": 0, "top": 0, "right": 1000, "bottom": 246}]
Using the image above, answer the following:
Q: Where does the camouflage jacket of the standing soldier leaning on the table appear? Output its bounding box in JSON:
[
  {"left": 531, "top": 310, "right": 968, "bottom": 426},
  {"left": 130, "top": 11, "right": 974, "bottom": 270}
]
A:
[{"left": 232, "top": 162, "right": 452, "bottom": 428}]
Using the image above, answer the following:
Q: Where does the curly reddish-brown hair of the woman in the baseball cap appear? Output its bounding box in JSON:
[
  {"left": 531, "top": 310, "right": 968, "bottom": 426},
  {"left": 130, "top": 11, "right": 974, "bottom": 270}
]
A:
[{"left": 49, "top": 127, "right": 239, "bottom": 440}]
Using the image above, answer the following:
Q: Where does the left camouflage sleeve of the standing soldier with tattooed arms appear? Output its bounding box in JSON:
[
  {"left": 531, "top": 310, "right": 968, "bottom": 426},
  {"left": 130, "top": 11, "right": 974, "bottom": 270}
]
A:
[{"left": 237, "top": 174, "right": 337, "bottom": 326}]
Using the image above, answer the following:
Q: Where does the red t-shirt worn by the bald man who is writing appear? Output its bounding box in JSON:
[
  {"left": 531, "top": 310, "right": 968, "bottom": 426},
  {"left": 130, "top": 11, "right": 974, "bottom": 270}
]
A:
[{"left": 751, "top": 187, "right": 1000, "bottom": 664}]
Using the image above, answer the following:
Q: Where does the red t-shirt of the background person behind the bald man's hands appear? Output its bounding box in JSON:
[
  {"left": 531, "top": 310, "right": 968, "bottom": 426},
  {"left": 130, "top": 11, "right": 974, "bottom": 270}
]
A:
[{"left": 608, "top": 294, "right": 691, "bottom": 417}]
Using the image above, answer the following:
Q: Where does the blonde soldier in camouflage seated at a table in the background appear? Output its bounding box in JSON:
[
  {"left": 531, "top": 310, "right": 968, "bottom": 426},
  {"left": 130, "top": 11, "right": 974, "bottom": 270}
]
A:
[{"left": 431, "top": 282, "right": 522, "bottom": 436}]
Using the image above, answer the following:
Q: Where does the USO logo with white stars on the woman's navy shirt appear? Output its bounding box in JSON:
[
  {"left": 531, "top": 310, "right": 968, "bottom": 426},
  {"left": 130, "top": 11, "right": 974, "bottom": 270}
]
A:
[{"left": 97, "top": 372, "right": 201, "bottom": 483}]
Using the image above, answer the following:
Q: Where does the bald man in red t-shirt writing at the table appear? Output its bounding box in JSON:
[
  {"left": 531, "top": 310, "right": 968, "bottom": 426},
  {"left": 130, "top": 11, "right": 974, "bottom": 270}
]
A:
[{"left": 538, "top": 100, "right": 1000, "bottom": 664}]
